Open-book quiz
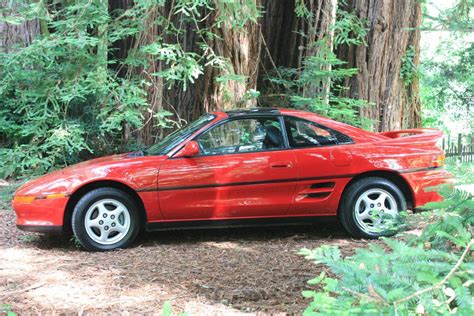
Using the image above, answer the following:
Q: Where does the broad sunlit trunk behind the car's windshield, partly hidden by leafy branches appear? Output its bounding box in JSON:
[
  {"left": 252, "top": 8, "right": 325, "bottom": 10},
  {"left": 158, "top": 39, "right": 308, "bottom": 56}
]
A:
[{"left": 129, "top": 0, "right": 261, "bottom": 144}]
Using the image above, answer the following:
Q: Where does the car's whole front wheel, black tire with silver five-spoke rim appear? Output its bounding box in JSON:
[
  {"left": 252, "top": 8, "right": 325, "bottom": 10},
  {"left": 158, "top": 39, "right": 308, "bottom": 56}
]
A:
[{"left": 72, "top": 188, "right": 140, "bottom": 251}]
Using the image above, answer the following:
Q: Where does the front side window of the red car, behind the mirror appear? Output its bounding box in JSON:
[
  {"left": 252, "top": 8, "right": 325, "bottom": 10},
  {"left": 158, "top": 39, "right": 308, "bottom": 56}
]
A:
[{"left": 196, "top": 117, "right": 284, "bottom": 155}]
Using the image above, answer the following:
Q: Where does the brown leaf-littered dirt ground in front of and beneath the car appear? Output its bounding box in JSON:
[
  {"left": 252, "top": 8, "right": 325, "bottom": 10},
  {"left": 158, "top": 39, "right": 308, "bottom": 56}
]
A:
[{"left": 0, "top": 194, "right": 376, "bottom": 315}]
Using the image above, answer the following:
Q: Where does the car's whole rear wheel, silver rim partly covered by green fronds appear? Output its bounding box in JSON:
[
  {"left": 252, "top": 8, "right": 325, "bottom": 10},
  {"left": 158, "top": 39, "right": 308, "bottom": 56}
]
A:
[{"left": 339, "top": 177, "right": 407, "bottom": 238}]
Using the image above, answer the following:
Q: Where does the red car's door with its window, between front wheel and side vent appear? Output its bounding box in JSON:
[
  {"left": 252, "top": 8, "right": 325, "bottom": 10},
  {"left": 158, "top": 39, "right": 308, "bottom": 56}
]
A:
[{"left": 158, "top": 116, "right": 297, "bottom": 220}]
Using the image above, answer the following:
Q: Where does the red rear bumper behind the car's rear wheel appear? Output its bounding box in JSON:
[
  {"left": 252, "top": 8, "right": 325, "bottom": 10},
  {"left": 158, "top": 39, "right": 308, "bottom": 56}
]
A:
[{"left": 402, "top": 168, "right": 454, "bottom": 208}]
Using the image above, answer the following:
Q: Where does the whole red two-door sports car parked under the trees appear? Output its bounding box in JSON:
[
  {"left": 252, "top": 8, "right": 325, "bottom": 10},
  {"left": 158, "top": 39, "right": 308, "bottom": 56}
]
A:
[{"left": 13, "top": 108, "right": 451, "bottom": 250}]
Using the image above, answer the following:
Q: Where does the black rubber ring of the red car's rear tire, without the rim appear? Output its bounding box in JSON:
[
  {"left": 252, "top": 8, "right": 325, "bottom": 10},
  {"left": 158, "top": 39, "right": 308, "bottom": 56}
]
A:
[{"left": 341, "top": 177, "right": 407, "bottom": 239}]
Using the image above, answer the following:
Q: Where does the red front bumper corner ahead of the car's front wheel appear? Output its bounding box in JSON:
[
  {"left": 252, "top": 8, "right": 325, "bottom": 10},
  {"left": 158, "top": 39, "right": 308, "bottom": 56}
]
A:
[{"left": 13, "top": 197, "right": 69, "bottom": 232}]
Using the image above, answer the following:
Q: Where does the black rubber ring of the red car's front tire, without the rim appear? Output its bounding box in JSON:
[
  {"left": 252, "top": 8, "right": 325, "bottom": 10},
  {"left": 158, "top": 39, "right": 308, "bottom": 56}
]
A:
[{"left": 72, "top": 188, "right": 140, "bottom": 251}]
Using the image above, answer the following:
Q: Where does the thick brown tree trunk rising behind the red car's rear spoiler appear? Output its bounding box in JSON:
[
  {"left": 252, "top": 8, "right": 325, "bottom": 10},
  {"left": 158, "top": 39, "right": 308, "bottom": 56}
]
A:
[{"left": 338, "top": 0, "right": 421, "bottom": 131}]
